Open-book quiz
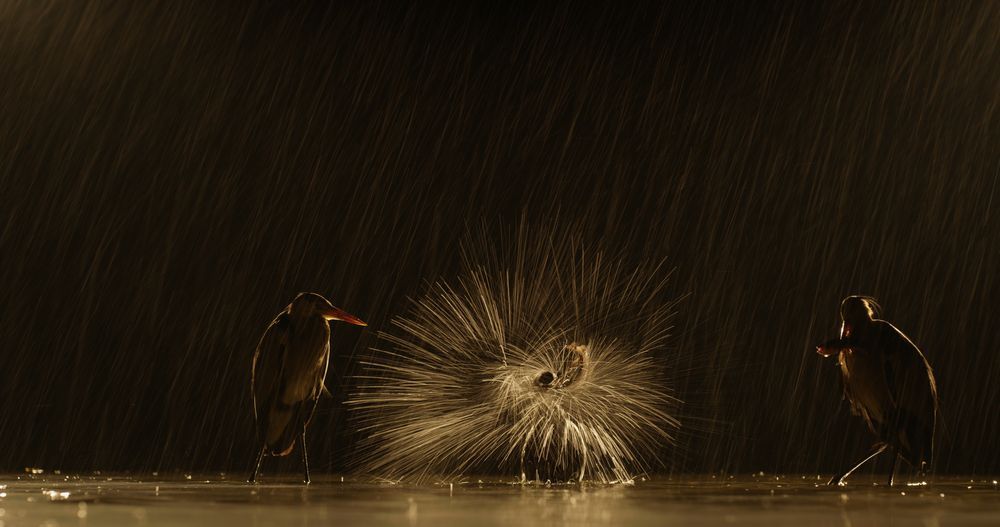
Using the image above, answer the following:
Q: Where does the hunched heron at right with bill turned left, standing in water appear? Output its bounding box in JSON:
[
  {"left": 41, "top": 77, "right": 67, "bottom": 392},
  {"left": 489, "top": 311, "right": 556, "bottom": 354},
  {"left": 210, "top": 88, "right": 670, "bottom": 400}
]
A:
[{"left": 816, "top": 296, "right": 938, "bottom": 486}]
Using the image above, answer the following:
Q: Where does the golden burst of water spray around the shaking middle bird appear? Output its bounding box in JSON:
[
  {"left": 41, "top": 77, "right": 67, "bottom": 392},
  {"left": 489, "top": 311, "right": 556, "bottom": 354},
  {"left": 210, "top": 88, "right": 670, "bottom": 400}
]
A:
[{"left": 349, "top": 232, "right": 680, "bottom": 482}]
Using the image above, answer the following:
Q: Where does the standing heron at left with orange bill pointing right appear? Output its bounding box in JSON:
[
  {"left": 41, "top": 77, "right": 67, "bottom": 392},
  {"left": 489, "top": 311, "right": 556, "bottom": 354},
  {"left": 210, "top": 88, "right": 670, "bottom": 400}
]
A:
[{"left": 250, "top": 293, "right": 367, "bottom": 484}]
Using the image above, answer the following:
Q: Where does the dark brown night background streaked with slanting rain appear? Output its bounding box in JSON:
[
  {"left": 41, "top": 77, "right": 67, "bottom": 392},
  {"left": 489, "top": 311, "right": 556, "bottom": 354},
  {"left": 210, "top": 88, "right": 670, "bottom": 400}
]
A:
[{"left": 0, "top": 0, "right": 1000, "bottom": 473}]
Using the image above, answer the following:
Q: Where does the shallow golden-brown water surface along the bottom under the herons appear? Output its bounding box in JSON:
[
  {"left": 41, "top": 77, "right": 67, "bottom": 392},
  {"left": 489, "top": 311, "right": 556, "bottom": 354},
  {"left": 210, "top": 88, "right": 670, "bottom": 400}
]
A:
[{"left": 0, "top": 473, "right": 1000, "bottom": 527}]
